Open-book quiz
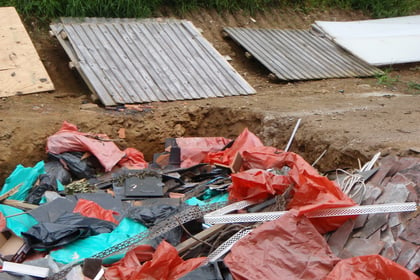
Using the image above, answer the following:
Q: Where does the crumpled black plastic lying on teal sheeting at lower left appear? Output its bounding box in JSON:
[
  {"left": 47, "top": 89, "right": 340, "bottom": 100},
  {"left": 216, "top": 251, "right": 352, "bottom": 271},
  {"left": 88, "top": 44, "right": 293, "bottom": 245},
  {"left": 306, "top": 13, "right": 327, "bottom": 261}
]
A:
[{"left": 22, "top": 213, "right": 116, "bottom": 249}]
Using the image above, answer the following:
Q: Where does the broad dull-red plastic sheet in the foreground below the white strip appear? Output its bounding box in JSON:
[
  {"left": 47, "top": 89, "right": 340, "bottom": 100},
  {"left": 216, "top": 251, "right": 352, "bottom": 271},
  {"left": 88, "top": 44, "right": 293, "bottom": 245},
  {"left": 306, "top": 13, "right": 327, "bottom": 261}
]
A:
[{"left": 224, "top": 210, "right": 339, "bottom": 280}]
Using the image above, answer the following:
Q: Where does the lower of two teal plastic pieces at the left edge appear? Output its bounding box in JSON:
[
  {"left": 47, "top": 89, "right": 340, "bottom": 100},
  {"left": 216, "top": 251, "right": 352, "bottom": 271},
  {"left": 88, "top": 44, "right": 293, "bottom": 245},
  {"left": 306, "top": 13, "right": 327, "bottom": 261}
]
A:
[{"left": 0, "top": 204, "right": 38, "bottom": 237}]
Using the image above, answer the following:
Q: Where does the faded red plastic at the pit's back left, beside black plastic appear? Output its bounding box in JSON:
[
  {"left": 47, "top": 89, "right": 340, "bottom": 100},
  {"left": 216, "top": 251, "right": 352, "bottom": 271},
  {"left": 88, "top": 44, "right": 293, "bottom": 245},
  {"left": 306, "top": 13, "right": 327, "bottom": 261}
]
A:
[{"left": 47, "top": 121, "right": 125, "bottom": 171}]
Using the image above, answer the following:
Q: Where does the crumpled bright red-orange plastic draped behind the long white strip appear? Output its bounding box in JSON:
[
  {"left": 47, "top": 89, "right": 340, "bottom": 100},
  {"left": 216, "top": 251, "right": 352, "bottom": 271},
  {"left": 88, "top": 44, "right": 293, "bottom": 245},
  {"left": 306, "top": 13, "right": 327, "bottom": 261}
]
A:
[{"left": 236, "top": 147, "right": 356, "bottom": 233}]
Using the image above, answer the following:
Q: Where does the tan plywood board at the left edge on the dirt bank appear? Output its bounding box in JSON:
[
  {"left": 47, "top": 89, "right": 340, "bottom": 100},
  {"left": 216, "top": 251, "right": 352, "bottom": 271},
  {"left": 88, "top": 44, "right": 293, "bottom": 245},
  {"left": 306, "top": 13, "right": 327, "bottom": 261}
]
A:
[{"left": 0, "top": 7, "right": 54, "bottom": 97}]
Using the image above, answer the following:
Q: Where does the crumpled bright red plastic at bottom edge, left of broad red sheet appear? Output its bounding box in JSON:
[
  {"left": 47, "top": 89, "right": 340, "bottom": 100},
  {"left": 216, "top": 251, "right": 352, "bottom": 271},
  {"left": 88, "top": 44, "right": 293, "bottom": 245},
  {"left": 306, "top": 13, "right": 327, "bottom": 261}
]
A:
[{"left": 105, "top": 240, "right": 206, "bottom": 280}]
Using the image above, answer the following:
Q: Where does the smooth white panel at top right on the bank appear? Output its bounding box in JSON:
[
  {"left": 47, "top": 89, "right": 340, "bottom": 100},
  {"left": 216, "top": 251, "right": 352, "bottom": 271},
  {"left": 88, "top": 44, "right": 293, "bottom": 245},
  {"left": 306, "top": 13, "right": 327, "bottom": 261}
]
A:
[{"left": 314, "top": 16, "right": 420, "bottom": 65}]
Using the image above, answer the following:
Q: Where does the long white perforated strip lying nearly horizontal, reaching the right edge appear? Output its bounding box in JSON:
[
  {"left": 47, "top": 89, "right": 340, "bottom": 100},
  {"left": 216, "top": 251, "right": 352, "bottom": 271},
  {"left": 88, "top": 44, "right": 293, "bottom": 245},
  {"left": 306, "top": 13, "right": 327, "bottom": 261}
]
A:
[{"left": 204, "top": 202, "right": 417, "bottom": 224}]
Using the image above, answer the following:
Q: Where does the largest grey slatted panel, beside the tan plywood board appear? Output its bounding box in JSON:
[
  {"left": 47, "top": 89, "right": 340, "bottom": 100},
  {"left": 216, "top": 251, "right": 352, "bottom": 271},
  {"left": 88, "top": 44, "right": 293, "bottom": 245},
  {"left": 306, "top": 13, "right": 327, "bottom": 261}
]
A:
[{"left": 51, "top": 18, "right": 255, "bottom": 106}]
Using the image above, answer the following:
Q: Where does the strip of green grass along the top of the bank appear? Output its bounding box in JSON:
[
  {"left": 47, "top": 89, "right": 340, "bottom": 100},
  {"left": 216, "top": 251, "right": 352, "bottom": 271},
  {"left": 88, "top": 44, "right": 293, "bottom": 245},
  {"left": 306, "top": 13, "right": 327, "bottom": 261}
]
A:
[{"left": 0, "top": 0, "right": 420, "bottom": 21}]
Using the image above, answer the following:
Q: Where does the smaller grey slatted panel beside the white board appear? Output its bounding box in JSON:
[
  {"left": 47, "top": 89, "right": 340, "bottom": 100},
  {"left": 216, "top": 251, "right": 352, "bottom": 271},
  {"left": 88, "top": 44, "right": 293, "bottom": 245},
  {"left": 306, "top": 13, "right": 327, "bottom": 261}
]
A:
[{"left": 224, "top": 28, "right": 381, "bottom": 80}]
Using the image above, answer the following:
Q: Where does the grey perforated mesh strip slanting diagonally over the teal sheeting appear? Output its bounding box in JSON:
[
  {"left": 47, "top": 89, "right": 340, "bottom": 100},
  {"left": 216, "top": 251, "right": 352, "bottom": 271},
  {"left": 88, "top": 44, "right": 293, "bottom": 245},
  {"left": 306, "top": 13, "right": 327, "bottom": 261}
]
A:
[{"left": 48, "top": 203, "right": 224, "bottom": 280}]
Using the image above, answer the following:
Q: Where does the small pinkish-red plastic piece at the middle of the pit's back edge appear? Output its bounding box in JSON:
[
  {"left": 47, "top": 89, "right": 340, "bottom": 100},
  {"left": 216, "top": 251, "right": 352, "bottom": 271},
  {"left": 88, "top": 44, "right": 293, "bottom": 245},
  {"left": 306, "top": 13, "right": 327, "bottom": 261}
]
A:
[{"left": 176, "top": 137, "right": 231, "bottom": 168}]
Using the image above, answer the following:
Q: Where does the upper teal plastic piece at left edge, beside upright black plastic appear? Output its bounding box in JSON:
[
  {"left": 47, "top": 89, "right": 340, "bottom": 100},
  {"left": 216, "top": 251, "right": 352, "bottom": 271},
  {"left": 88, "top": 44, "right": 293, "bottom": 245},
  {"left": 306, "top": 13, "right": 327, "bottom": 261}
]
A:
[{"left": 0, "top": 161, "right": 45, "bottom": 201}]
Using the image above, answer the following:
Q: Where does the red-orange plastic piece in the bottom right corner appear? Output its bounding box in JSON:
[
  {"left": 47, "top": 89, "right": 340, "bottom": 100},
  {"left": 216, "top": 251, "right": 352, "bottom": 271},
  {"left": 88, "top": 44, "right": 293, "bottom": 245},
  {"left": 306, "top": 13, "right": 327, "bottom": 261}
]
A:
[{"left": 324, "top": 255, "right": 420, "bottom": 280}]
